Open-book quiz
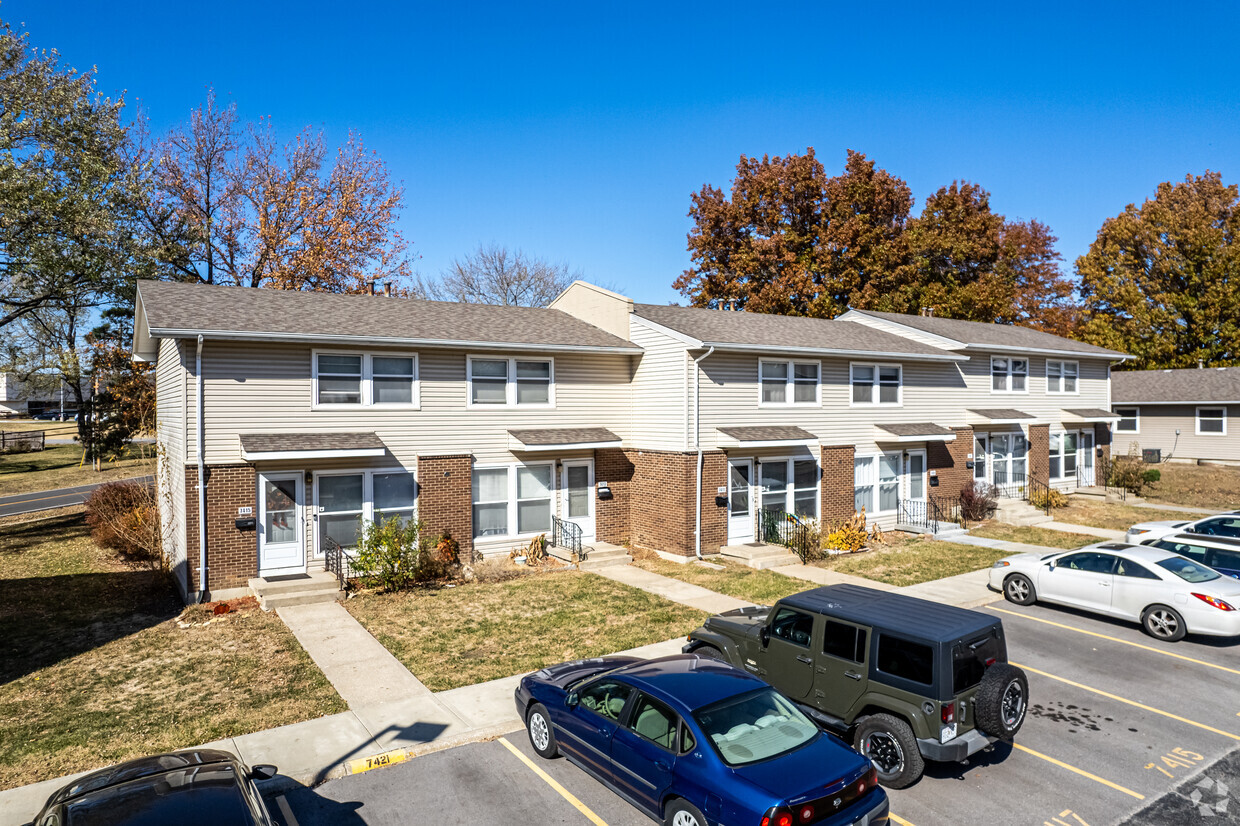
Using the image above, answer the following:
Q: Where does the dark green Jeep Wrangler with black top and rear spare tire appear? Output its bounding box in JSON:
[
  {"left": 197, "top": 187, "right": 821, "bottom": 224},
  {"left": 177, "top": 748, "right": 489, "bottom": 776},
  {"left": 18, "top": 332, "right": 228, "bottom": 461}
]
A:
[{"left": 684, "top": 577, "right": 1029, "bottom": 789}]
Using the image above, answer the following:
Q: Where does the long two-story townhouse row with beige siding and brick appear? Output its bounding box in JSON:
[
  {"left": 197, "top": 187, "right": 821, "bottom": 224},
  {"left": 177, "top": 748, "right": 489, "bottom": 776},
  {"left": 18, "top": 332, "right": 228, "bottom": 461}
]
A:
[{"left": 134, "top": 276, "right": 1123, "bottom": 595}]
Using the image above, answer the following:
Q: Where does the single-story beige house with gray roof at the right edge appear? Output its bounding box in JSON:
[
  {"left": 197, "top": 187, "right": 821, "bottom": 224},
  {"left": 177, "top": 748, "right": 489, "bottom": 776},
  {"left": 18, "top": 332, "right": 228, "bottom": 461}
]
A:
[{"left": 1111, "top": 367, "right": 1240, "bottom": 463}]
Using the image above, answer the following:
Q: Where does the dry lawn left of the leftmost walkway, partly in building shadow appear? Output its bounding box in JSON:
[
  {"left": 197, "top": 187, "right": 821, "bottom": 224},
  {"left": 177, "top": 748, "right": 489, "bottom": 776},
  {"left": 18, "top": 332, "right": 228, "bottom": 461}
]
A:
[{"left": 0, "top": 516, "right": 345, "bottom": 789}]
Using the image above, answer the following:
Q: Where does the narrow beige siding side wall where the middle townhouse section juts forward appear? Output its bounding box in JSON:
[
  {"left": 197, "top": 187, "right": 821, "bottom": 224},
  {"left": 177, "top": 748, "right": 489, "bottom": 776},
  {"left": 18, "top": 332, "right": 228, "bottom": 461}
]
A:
[{"left": 629, "top": 322, "right": 689, "bottom": 450}]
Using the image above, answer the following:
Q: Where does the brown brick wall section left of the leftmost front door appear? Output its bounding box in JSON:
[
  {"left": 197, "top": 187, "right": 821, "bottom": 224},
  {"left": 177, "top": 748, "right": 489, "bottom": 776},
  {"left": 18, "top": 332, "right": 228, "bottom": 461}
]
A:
[{"left": 185, "top": 465, "right": 258, "bottom": 594}]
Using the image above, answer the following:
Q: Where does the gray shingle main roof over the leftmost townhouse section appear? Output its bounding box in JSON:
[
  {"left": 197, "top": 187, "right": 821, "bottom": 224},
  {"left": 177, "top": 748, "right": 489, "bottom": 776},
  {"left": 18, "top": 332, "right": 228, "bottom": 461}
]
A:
[{"left": 138, "top": 282, "right": 641, "bottom": 352}]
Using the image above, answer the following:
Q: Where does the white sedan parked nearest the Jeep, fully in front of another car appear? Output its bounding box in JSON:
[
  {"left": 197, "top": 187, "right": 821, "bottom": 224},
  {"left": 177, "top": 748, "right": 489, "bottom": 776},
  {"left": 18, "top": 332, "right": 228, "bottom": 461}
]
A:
[{"left": 991, "top": 542, "right": 1240, "bottom": 642}]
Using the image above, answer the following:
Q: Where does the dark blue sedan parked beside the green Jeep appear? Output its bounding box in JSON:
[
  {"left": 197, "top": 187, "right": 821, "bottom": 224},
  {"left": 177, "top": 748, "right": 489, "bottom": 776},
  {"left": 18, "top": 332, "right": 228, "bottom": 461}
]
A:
[{"left": 516, "top": 654, "right": 888, "bottom": 826}]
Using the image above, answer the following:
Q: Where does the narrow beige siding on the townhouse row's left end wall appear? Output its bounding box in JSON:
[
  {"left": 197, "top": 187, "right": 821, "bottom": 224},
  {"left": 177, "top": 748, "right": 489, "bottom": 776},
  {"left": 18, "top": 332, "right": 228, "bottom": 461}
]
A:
[{"left": 155, "top": 339, "right": 188, "bottom": 599}]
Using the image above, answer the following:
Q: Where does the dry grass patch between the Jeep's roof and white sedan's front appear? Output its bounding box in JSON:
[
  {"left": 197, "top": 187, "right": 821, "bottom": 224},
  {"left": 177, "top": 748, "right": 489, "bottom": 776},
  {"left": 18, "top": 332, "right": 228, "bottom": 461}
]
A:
[{"left": 812, "top": 538, "right": 1012, "bottom": 585}]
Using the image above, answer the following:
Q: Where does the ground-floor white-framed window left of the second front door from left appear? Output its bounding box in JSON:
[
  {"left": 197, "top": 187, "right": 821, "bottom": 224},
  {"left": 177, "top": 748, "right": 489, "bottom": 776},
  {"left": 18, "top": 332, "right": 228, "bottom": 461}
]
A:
[{"left": 474, "top": 463, "right": 556, "bottom": 538}]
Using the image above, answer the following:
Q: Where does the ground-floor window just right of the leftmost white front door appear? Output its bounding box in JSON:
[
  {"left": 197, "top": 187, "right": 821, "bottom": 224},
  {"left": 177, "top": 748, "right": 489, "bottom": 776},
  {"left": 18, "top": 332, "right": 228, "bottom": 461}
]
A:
[{"left": 315, "top": 469, "right": 417, "bottom": 554}]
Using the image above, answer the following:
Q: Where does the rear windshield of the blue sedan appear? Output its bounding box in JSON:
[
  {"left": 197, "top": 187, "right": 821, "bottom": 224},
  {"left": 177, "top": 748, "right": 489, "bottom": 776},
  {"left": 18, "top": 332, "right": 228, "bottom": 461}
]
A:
[{"left": 693, "top": 688, "right": 820, "bottom": 765}]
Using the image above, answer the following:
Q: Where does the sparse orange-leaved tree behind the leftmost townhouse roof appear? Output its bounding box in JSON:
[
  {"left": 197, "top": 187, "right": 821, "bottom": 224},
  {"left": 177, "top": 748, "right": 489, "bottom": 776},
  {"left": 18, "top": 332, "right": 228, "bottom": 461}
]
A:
[{"left": 139, "top": 91, "right": 410, "bottom": 293}]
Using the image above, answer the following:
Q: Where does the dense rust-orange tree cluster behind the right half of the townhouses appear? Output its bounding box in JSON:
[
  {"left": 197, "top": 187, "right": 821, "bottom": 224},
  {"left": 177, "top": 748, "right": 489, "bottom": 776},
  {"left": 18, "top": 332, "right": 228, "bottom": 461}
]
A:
[{"left": 675, "top": 146, "right": 1075, "bottom": 334}]
